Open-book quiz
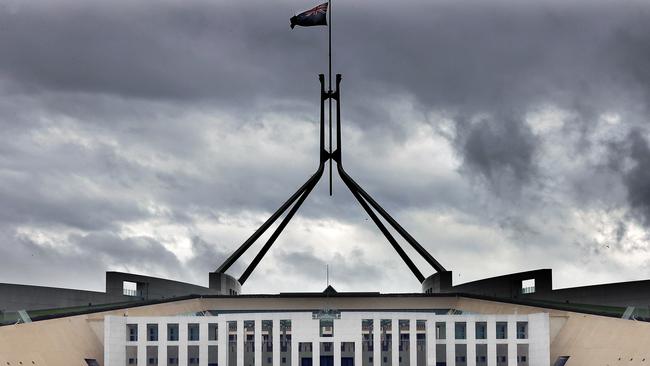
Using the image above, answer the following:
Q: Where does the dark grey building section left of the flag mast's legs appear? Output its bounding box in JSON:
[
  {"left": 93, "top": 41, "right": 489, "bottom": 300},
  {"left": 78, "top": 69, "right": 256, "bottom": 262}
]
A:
[{"left": 0, "top": 272, "right": 241, "bottom": 311}]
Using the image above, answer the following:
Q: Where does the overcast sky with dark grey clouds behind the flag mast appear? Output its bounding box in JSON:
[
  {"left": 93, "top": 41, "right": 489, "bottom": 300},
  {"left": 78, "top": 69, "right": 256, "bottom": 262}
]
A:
[{"left": 0, "top": 0, "right": 650, "bottom": 293}]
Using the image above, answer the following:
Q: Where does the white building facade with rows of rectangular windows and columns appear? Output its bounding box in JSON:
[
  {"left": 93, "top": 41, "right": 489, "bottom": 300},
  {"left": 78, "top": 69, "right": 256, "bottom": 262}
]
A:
[{"left": 104, "top": 310, "right": 550, "bottom": 366}]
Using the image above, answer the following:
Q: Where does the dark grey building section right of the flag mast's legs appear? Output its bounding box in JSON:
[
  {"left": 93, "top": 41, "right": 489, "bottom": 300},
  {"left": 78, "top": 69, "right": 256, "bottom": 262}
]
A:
[{"left": 422, "top": 269, "right": 650, "bottom": 308}]
